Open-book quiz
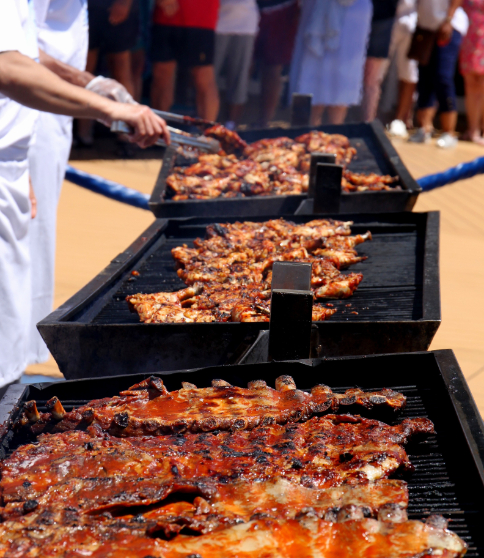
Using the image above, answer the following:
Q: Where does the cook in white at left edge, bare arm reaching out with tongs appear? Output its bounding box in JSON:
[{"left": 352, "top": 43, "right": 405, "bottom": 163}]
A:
[{"left": 0, "top": 0, "right": 169, "bottom": 398}]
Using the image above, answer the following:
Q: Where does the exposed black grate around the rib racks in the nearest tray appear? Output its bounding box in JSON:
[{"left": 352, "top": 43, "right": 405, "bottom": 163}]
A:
[{"left": 3, "top": 385, "right": 484, "bottom": 558}]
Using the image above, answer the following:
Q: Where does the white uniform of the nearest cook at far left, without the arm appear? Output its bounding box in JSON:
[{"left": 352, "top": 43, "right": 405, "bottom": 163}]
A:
[{"left": 0, "top": 0, "right": 38, "bottom": 387}]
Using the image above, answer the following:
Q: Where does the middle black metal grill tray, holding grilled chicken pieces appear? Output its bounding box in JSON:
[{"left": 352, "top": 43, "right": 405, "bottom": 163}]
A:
[{"left": 38, "top": 212, "right": 440, "bottom": 379}]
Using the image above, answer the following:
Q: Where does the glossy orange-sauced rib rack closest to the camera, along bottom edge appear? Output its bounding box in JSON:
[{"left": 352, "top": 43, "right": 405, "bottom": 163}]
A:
[{"left": 0, "top": 508, "right": 466, "bottom": 558}]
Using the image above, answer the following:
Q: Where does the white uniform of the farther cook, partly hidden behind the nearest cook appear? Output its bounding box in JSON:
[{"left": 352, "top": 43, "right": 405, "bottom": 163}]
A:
[{"left": 29, "top": 0, "right": 89, "bottom": 364}]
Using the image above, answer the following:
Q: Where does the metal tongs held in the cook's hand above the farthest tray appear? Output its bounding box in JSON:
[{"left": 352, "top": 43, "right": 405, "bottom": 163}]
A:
[{"left": 111, "top": 109, "right": 221, "bottom": 153}]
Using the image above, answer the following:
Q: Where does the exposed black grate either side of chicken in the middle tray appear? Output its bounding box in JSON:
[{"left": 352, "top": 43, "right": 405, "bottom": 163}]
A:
[{"left": 92, "top": 228, "right": 423, "bottom": 324}]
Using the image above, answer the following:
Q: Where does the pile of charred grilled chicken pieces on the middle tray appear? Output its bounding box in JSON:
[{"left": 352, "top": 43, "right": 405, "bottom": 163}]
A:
[{"left": 126, "top": 219, "right": 371, "bottom": 323}]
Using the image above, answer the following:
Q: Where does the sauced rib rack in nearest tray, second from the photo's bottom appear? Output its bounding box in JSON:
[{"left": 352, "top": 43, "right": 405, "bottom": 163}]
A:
[{"left": 1, "top": 476, "right": 408, "bottom": 536}]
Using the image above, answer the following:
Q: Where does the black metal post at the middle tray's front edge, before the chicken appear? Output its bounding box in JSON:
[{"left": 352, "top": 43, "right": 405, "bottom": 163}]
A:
[{"left": 269, "top": 262, "right": 313, "bottom": 360}]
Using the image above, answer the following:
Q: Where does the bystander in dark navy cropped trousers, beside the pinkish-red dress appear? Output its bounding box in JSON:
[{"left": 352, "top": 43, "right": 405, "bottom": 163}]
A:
[{"left": 409, "top": 0, "right": 469, "bottom": 149}]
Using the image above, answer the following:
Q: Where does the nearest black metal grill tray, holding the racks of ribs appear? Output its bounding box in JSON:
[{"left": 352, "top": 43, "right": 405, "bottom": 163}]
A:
[{"left": 0, "top": 350, "right": 484, "bottom": 558}]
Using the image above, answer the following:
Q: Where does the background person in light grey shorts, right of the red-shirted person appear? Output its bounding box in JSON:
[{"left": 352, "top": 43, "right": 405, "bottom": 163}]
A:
[{"left": 214, "top": 0, "right": 259, "bottom": 129}]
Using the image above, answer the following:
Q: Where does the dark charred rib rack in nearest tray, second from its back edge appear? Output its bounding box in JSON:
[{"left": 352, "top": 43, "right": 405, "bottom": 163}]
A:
[{"left": 0, "top": 415, "right": 434, "bottom": 504}]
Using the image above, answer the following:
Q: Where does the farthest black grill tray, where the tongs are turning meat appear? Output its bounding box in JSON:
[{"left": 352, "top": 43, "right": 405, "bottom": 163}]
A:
[{"left": 149, "top": 121, "right": 421, "bottom": 218}]
